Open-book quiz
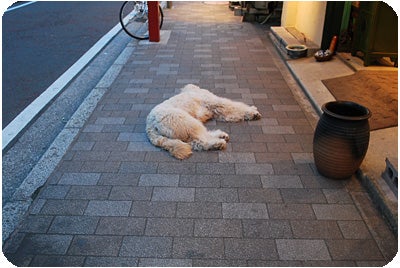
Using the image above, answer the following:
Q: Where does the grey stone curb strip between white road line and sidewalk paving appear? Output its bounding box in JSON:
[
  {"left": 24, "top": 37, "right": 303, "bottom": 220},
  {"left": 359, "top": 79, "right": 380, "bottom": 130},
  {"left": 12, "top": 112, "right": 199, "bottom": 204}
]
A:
[{"left": 2, "top": 40, "right": 135, "bottom": 244}]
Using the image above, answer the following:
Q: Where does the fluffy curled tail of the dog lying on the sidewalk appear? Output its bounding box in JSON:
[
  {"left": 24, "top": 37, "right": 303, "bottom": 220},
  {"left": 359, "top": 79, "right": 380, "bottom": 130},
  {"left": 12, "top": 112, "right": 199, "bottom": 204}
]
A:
[{"left": 146, "top": 127, "right": 192, "bottom": 159}]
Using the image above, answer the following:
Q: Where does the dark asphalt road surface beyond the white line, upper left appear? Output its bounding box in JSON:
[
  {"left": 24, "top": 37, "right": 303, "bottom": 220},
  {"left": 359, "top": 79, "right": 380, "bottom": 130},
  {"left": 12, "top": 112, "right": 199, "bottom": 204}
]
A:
[{"left": 2, "top": 1, "right": 122, "bottom": 128}]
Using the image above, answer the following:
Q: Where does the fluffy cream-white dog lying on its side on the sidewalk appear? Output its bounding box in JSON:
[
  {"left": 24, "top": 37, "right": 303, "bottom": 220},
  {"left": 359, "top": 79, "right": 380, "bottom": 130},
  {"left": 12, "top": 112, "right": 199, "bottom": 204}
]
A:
[{"left": 146, "top": 84, "right": 261, "bottom": 159}]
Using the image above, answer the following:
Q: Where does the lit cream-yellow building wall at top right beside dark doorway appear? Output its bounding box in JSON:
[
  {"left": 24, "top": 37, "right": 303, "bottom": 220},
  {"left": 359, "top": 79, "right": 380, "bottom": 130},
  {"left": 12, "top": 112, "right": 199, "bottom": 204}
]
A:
[{"left": 281, "top": 1, "right": 326, "bottom": 45}]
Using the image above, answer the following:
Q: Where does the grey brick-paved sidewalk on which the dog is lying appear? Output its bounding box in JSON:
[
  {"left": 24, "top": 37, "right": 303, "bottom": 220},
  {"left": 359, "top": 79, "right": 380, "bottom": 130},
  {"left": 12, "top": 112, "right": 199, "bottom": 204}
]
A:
[{"left": 3, "top": 2, "right": 397, "bottom": 266}]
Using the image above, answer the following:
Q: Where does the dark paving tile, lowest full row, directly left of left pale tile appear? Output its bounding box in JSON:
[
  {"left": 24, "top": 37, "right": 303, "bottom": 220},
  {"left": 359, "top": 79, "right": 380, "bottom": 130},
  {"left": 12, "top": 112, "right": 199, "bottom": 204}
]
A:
[{"left": 68, "top": 235, "right": 122, "bottom": 256}]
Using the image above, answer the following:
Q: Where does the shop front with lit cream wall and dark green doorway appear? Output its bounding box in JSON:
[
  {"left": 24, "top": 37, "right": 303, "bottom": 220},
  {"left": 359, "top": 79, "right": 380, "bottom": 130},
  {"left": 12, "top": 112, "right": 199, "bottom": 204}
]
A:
[{"left": 281, "top": 1, "right": 398, "bottom": 66}]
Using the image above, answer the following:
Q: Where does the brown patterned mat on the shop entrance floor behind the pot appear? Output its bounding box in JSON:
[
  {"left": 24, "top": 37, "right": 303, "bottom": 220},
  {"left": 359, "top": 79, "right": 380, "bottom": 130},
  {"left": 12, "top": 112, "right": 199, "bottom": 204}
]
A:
[{"left": 322, "top": 70, "right": 398, "bottom": 130}]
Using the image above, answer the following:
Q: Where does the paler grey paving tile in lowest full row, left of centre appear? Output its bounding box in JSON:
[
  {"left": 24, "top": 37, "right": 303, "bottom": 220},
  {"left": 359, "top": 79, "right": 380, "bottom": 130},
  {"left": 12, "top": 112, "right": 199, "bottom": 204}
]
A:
[{"left": 119, "top": 236, "right": 172, "bottom": 258}]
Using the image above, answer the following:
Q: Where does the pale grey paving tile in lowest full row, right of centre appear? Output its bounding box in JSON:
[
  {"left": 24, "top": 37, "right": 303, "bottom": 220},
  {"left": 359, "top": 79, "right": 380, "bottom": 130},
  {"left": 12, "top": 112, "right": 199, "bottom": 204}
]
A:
[{"left": 276, "top": 239, "right": 331, "bottom": 261}]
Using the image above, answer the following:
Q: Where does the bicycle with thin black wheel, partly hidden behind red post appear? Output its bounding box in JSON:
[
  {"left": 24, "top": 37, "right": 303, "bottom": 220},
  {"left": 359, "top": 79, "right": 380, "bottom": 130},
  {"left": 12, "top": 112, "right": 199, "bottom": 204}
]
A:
[{"left": 119, "top": 1, "right": 164, "bottom": 40}]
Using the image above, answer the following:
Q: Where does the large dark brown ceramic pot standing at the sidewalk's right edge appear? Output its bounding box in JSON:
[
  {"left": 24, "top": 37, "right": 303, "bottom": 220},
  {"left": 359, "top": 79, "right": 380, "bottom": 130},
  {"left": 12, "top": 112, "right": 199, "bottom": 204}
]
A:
[{"left": 313, "top": 101, "right": 371, "bottom": 179}]
